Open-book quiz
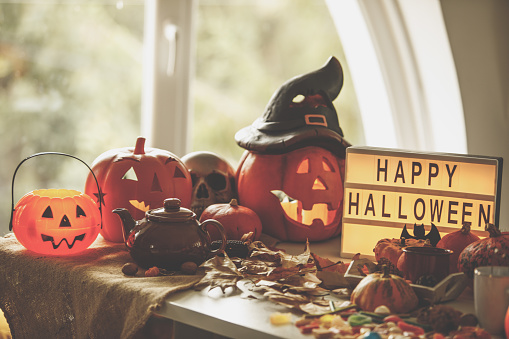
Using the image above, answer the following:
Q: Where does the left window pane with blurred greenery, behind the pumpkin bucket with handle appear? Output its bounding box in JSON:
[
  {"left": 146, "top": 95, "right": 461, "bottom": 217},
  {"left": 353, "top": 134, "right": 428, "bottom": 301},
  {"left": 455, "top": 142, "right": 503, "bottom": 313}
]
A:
[{"left": 0, "top": 1, "right": 144, "bottom": 234}]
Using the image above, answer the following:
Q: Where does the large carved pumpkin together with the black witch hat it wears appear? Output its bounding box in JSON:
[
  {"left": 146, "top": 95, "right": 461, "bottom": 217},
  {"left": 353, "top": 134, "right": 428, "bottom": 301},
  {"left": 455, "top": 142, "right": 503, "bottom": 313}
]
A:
[{"left": 235, "top": 57, "right": 350, "bottom": 241}]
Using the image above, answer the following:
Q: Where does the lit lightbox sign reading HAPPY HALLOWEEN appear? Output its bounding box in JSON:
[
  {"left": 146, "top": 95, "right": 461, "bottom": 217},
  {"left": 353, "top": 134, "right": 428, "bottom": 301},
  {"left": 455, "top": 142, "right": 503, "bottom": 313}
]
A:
[{"left": 341, "top": 147, "right": 502, "bottom": 257}]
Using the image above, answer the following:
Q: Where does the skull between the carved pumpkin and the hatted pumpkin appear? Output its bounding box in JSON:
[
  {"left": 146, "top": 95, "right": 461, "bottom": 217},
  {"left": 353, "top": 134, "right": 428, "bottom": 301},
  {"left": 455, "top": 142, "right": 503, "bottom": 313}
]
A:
[{"left": 182, "top": 151, "right": 237, "bottom": 218}]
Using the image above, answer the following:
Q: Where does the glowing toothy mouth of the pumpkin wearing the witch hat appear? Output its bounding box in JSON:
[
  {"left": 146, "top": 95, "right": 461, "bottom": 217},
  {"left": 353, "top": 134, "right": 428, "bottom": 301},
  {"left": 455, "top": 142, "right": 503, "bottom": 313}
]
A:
[{"left": 271, "top": 190, "right": 338, "bottom": 226}]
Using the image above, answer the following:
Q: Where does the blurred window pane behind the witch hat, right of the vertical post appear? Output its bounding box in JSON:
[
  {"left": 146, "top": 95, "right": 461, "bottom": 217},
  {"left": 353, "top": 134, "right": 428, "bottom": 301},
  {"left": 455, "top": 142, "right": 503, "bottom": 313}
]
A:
[{"left": 192, "top": 0, "right": 364, "bottom": 166}]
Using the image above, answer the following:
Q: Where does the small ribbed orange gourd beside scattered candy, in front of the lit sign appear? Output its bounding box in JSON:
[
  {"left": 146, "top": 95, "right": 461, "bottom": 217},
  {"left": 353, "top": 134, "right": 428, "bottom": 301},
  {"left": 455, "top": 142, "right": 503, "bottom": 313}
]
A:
[{"left": 350, "top": 266, "right": 419, "bottom": 313}]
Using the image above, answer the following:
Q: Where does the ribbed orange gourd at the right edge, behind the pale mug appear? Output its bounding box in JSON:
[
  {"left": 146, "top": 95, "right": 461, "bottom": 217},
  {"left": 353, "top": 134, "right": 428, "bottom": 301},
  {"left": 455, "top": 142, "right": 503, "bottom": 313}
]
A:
[{"left": 458, "top": 224, "right": 509, "bottom": 282}]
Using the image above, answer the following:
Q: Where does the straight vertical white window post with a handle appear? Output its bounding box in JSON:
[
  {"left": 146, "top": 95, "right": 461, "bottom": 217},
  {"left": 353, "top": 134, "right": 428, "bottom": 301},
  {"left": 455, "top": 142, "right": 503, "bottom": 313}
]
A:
[{"left": 141, "top": 0, "right": 197, "bottom": 157}]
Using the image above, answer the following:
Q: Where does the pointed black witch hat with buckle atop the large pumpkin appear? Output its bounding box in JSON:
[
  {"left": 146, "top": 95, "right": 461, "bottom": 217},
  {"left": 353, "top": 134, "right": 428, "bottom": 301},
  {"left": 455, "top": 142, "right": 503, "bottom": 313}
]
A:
[{"left": 235, "top": 57, "right": 350, "bottom": 158}]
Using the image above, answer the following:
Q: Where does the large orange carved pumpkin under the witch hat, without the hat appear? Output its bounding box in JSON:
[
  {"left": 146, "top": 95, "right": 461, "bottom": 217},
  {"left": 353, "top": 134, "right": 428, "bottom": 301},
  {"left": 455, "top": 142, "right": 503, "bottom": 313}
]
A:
[{"left": 237, "top": 146, "right": 344, "bottom": 241}]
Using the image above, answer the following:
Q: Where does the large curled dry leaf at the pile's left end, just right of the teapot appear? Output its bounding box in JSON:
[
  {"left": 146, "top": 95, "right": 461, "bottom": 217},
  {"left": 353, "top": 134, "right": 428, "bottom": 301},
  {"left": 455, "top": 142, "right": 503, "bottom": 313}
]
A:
[{"left": 194, "top": 254, "right": 243, "bottom": 293}]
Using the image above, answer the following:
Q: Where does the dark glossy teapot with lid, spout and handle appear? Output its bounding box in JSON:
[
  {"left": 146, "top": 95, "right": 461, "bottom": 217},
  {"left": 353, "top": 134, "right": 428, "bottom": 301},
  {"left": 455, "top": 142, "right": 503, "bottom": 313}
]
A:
[{"left": 113, "top": 198, "right": 226, "bottom": 270}]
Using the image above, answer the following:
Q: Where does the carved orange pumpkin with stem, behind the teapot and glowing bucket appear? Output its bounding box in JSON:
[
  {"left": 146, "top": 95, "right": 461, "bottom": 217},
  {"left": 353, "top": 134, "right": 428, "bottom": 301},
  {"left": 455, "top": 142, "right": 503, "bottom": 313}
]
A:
[{"left": 85, "top": 137, "right": 192, "bottom": 243}]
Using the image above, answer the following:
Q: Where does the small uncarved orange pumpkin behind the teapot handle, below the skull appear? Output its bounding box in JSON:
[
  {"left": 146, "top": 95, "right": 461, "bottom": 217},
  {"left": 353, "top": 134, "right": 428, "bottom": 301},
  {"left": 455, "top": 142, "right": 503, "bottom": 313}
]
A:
[{"left": 200, "top": 199, "right": 262, "bottom": 240}]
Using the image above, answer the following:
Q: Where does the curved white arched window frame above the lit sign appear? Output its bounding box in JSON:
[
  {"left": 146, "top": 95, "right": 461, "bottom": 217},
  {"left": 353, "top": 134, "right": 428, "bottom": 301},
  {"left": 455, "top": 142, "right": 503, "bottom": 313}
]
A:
[{"left": 327, "top": 0, "right": 467, "bottom": 153}]
